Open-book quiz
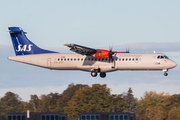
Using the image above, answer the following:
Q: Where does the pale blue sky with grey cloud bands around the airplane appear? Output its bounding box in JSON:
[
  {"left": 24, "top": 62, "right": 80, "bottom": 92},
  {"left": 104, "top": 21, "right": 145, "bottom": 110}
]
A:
[{"left": 0, "top": 0, "right": 180, "bottom": 101}]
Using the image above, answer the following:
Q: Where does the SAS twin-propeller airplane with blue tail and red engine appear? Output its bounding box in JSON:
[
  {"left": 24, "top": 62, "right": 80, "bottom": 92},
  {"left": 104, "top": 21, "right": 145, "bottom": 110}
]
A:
[{"left": 6, "top": 27, "right": 177, "bottom": 78}]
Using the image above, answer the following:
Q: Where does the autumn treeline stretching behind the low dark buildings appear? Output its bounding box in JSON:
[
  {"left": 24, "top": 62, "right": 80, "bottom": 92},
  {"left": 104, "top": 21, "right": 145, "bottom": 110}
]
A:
[{"left": 0, "top": 84, "right": 180, "bottom": 120}]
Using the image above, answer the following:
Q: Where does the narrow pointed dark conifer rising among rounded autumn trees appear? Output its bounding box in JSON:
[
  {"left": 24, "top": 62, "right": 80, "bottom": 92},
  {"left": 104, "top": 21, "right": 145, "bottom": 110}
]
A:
[{"left": 124, "top": 88, "right": 137, "bottom": 113}]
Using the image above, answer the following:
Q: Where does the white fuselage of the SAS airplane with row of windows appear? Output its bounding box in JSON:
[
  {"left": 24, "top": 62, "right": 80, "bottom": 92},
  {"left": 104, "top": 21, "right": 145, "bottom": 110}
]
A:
[{"left": 8, "top": 53, "right": 176, "bottom": 72}]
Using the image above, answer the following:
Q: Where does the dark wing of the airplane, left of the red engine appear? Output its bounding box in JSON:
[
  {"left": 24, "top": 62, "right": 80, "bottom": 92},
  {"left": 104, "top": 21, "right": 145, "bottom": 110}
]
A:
[{"left": 64, "top": 44, "right": 97, "bottom": 56}]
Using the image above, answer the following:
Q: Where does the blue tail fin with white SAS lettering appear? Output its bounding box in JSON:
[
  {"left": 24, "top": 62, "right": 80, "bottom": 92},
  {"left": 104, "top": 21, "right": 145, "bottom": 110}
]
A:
[{"left": 8, "top": 27, "right": 57, "bottom": 55}]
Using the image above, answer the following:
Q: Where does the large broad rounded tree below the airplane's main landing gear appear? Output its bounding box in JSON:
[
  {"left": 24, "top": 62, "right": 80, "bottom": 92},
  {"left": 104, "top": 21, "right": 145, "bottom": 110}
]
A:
[{"left": 64, "top": 84, "right": 125, "bottom": 119}]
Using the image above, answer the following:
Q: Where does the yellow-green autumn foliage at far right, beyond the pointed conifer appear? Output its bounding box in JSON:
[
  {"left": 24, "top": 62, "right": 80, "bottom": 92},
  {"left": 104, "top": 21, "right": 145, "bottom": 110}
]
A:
[{"left": 137, "top": 91, "right": 180, "bottom": 120}]
